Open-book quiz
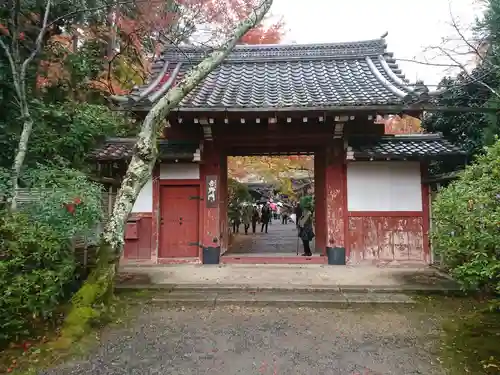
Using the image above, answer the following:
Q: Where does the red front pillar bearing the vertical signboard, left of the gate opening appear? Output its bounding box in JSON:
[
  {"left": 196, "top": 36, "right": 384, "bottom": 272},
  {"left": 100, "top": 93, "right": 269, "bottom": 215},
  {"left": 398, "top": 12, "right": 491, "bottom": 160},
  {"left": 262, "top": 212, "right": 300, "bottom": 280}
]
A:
[{"left": 200, "top": 142, "right": 221, "bottom": 256}]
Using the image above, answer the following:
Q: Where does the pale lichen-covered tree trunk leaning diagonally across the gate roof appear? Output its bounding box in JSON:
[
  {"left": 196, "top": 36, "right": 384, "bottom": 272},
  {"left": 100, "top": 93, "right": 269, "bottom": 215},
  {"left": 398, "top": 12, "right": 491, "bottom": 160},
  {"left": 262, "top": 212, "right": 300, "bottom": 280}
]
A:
[{"left": 103, "top": 0, "right": 273, "bottom": 255}]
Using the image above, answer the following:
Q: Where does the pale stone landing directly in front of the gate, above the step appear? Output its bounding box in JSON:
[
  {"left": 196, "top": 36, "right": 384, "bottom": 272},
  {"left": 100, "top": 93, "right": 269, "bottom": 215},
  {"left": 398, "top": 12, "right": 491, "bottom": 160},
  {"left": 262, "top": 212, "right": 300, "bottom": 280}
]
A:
[{"left": 121, "top": 264, "right": 456, "bottom": 291}]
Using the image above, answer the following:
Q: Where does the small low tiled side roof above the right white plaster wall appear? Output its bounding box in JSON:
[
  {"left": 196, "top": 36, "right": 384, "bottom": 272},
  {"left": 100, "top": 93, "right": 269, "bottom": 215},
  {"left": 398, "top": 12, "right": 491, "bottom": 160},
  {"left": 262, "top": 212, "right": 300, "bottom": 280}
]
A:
[{"left": 347, "top": 134, "right": 465, "bottom": 159}]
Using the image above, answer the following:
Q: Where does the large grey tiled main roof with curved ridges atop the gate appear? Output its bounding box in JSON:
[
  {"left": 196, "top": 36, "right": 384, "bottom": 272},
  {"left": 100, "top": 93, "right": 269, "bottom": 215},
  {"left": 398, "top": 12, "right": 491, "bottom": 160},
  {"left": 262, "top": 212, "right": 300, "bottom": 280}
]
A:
[{"left": 109, "top": 39, "right": 428, "bottom": 111}]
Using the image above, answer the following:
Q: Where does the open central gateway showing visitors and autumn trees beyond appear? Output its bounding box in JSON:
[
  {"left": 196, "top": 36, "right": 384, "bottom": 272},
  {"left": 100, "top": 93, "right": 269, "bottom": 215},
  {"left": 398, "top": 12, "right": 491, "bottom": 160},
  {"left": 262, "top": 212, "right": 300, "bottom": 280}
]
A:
[{"left": 223, "top": 153, "right": 323, "bottom": 262}]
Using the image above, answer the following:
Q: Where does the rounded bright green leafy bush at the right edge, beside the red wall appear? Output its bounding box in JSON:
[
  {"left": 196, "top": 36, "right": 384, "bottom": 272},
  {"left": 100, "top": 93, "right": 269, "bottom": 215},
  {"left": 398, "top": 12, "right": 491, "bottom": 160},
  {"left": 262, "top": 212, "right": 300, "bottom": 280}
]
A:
[{"left": 432, "top": 141, "right": 500, "bottom": 293}]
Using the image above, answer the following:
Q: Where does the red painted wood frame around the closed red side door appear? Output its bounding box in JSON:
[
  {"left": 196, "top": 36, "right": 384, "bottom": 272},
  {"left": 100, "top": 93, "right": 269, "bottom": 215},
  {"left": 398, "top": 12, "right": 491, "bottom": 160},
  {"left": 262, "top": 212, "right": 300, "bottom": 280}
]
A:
[{"left": 151, "top": 175, "right": 203, "bottom": 264}]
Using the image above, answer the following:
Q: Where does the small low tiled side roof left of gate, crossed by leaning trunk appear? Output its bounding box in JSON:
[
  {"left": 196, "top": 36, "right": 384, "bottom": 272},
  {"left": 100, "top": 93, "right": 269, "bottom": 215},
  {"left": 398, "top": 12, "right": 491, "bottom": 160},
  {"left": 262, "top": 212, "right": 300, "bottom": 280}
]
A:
[{"left": 89, "top": 138, "right": 199, "bottom": 161}]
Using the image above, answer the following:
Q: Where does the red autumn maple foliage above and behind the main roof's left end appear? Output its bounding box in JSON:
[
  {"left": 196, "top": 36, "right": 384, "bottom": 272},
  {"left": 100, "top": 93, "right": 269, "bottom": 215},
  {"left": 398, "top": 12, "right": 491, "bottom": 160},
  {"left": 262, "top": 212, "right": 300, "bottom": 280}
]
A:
[{"left": 33, "top": 0, "right": 284, "bottom": 94}]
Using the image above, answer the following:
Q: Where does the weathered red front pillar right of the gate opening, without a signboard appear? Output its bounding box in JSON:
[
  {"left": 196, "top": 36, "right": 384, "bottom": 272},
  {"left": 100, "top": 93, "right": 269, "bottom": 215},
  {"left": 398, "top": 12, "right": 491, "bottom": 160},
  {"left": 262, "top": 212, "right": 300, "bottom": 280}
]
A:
[{"left": 325, "top": 141, "right": 349, "bottom": 258}]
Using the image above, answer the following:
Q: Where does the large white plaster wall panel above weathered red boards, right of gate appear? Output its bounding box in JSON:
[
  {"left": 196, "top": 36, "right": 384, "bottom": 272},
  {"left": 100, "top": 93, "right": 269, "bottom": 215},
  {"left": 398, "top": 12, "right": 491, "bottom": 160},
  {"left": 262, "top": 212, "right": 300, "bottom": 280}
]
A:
[{"left": 347, "top": 161, "right": 422, "bottom": 211}]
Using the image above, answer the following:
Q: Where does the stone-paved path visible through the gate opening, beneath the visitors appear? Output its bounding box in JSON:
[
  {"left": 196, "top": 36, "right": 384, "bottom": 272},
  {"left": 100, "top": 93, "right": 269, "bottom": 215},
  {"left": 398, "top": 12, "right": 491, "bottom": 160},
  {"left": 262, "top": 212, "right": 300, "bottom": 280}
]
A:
[{"left": 226, "top": 220, "right": 314, "bottom": 256}]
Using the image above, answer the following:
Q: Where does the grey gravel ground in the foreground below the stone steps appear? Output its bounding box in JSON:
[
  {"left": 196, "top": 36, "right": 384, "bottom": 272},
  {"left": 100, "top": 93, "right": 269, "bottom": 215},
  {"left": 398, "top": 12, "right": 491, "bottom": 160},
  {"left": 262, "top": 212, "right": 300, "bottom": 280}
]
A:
[{"left": 43, "top": 306, "right": 443, "bottom": 375}]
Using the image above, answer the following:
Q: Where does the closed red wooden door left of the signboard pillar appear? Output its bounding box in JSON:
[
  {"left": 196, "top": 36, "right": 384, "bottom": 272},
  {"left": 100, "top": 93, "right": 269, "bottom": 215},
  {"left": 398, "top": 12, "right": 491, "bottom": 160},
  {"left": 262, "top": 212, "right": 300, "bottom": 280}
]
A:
[{"left": 158, "top": 186, "right": 200, "bottom": 258}]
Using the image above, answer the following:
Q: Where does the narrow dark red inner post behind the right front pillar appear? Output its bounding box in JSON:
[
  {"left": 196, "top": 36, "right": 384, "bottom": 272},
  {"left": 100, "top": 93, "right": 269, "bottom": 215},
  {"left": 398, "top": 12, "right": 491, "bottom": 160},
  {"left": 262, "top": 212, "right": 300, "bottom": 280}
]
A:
[{"left": 314, "top": 150, "right": 327, "bottom": 254}]
